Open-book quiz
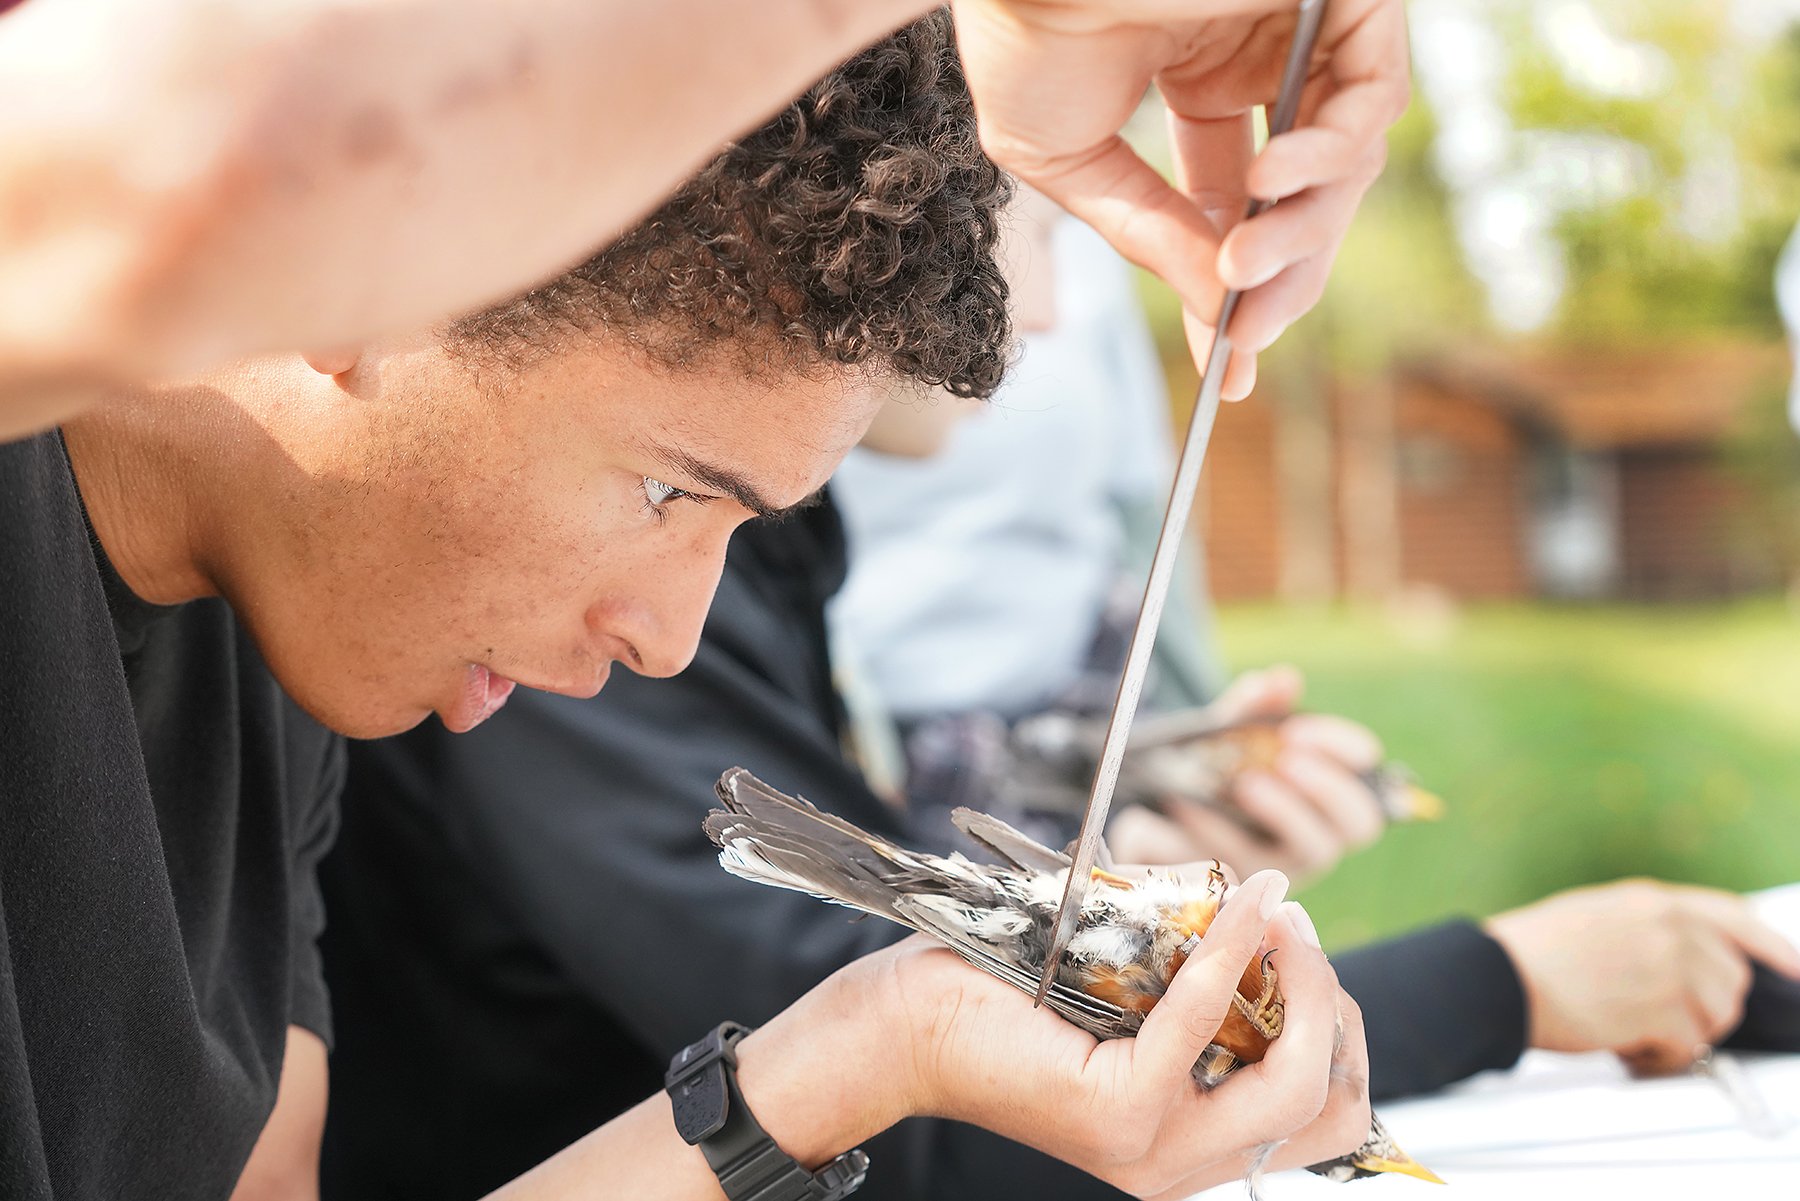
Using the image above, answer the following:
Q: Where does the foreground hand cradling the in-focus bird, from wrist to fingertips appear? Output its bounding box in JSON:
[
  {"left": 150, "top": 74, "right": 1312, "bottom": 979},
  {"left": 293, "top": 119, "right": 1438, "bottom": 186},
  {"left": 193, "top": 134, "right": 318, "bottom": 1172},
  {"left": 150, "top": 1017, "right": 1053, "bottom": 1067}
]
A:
[{"left": 844, "top": 873, "right": 1368, "bottom": 1197}]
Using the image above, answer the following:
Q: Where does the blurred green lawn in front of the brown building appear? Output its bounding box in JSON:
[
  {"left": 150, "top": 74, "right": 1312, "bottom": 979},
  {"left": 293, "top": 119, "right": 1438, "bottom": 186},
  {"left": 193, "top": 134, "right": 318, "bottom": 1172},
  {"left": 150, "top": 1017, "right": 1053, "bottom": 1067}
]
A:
[{"left": 1219, "top": 601, "right": 1800, "bottom": 947}]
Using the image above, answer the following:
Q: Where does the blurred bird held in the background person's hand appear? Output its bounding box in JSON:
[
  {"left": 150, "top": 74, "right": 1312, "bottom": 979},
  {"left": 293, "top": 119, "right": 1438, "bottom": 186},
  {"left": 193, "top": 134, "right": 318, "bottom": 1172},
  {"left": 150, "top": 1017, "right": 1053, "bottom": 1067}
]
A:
[{"left": 1006, "top": 708, "right": 1444, "bottom": 834}]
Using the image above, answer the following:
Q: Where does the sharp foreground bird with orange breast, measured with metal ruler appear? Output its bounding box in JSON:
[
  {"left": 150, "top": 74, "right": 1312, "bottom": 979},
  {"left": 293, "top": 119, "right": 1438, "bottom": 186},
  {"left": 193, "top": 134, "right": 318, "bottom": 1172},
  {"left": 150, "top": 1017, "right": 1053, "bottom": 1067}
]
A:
[{"left": 706, "top": 767, "right": 1444, "bottom": 1197}]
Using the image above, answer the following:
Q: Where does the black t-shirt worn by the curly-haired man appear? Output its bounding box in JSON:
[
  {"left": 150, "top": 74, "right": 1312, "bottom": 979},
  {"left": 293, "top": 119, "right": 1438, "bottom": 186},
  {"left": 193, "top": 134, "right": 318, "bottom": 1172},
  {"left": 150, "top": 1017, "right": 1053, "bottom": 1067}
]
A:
[{"left": 0, "top": 434, "right": 342, "bottom": 1201}]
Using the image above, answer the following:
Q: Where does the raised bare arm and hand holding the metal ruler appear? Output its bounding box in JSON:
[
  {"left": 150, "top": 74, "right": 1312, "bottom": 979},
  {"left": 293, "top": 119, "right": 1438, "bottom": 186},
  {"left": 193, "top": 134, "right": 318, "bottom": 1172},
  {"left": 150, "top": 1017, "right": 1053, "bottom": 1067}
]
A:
[{"left": 0, "top": 0, "right": 1408, "bottom": 438}]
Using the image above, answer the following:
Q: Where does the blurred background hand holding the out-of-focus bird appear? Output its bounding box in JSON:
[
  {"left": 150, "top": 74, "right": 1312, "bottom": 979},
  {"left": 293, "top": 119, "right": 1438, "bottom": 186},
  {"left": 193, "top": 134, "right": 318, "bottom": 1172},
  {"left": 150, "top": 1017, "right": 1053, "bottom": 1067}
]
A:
[{"left": 1107, "top": 666, "right": 1388, "bottom": 880}]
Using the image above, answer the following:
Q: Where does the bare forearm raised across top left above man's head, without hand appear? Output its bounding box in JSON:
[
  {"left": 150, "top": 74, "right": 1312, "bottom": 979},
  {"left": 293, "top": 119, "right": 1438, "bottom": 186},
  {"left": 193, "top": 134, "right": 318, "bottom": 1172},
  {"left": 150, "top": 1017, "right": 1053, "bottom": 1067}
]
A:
[{"left": 0, "top": 0, "right": 929, "bottom": 438}]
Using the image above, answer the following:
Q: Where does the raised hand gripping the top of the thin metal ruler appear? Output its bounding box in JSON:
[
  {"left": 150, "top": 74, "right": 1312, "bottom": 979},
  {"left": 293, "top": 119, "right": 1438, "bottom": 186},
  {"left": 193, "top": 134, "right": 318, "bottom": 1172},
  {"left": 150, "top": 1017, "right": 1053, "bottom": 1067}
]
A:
[{"left": 952, "top": 0, "right": 1409, "bottom": 400}]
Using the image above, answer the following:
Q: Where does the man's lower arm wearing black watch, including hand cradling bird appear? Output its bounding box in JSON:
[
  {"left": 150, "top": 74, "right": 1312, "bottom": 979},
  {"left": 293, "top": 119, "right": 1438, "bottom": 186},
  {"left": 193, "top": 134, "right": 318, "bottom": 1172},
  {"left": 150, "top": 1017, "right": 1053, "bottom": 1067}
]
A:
[{"left": 238, "top": 873, "right": 1368, "bottom": 1201}]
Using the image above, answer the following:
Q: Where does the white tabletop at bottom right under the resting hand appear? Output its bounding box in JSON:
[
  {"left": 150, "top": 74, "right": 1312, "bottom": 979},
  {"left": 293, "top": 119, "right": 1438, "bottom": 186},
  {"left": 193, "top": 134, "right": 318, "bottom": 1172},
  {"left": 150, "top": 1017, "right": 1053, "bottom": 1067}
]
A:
[{"left": 1202, "top": 884, "right": 1800, "bottom": 1201}]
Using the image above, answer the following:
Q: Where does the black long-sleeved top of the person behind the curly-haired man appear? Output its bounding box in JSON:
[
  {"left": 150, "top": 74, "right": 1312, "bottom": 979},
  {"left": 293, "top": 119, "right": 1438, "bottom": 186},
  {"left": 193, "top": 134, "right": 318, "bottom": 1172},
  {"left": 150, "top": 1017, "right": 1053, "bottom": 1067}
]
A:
[{"left": 324, "top": 489, "right": 1523, "bottom": 1201}]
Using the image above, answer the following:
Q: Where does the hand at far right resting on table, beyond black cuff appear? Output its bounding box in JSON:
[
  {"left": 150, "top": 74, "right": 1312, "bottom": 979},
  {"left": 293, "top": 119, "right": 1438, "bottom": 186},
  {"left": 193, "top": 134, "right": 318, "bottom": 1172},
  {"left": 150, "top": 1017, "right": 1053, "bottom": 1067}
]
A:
[{"left": 1485, "top": 880, "right": 1800, "bottom": 1068}]
